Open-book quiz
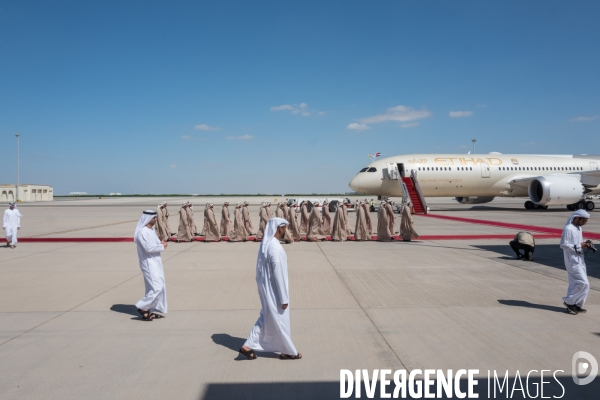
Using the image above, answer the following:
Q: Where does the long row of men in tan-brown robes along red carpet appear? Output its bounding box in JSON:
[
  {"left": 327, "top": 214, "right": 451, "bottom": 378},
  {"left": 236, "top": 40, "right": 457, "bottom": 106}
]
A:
[{"left": 156, "top": 200, "right": 419, "bottom": 243}]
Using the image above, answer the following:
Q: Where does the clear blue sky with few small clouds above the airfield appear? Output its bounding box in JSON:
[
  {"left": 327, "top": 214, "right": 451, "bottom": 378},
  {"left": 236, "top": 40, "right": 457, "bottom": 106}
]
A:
[{"left": 0, "top": 0, "right": 600, "bottom": 194}]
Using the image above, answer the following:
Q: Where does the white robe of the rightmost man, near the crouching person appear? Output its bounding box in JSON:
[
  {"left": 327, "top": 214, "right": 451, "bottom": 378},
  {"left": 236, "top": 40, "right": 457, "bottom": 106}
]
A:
[{"left": 560, "top": 223, "right": 590, "bottom": 307}]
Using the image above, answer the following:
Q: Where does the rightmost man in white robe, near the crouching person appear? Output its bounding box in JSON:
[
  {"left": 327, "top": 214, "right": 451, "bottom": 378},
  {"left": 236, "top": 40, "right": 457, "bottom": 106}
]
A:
[{"left": 560, "top": 210, "right": 595, "bottom": 315}]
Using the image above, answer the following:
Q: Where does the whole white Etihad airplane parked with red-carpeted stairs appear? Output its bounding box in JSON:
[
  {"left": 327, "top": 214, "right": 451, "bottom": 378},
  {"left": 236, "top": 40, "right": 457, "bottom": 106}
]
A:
[{"left": 350, "top": 153, "right": 600, "bottom": 211}]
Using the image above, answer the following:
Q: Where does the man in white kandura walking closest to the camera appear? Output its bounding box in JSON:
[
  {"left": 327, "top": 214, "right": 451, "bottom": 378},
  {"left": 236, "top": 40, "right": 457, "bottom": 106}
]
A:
[{"left": 239, "top": 218, "right": 302, "bottom": 360}]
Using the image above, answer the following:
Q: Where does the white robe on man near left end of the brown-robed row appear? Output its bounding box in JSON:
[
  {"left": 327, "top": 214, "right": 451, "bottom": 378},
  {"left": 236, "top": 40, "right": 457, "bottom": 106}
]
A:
[{"left": 135, "top": 227, "right": 167, "bottom": 313}]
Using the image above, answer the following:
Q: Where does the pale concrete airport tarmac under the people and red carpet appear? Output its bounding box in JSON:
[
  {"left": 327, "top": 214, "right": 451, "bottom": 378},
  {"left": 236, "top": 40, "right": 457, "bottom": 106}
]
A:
[{"left": 0, "top": 197, "right": 600, "bottom": 399}]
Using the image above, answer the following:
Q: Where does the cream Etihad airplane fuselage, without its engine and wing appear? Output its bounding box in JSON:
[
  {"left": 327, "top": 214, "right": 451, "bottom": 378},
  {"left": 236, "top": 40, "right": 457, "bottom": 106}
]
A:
[{"left": 350, "top": 153, "right": 600, "bottom": 202}]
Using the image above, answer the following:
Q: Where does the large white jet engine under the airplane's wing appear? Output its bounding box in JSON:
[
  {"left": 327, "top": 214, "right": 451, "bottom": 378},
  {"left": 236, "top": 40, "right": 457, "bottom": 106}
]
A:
[{"left": 529, "top": 176, "right": 584, "bottom": 206}]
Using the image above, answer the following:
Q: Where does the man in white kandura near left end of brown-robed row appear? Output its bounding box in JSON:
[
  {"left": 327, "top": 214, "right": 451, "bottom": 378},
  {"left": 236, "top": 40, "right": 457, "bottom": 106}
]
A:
[{"left": 133, "top": 210, "right": 167, "bottom": 321}]
